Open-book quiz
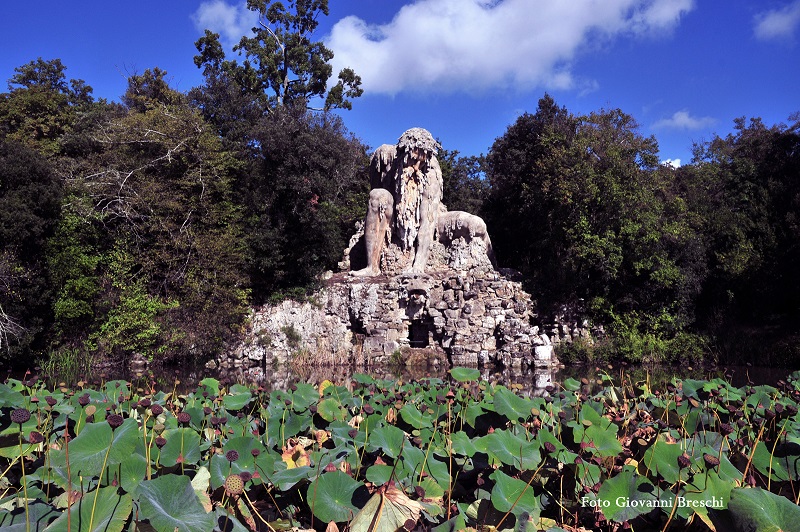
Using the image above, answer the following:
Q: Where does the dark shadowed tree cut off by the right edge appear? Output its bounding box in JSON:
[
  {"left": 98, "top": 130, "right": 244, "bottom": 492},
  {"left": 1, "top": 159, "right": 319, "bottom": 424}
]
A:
[{"left": 681, "top": 116, "right": 800, "bottom": 360}]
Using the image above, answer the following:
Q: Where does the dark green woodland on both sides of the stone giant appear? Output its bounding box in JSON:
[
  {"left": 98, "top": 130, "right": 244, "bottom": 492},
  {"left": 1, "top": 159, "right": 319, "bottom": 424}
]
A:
[{"left": 0, "top": 47, "right": 800, "bottom": 370}]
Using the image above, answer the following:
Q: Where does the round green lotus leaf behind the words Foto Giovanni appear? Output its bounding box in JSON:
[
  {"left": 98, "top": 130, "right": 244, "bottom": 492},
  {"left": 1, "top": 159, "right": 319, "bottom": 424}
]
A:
[{"left": 597, "top": 468, "right": 660, "bottom": 523}]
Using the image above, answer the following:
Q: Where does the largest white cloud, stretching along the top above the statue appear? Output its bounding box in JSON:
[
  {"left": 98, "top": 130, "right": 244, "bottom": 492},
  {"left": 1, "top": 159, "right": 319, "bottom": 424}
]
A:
[{"left": 326, "top": 0, "right": 694, "bottom": 94}]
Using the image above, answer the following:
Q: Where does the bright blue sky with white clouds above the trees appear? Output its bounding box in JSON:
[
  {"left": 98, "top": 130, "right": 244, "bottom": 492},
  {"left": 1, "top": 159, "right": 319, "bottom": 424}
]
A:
[{"left": 0, "top": 0, "right": 800, "bottom": 164}]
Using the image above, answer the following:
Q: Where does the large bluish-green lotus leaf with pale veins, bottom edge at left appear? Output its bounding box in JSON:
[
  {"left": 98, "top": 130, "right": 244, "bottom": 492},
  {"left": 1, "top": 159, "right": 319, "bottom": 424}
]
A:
[{"left": 139, "top": 475, "right": 214, "bottom": 532}]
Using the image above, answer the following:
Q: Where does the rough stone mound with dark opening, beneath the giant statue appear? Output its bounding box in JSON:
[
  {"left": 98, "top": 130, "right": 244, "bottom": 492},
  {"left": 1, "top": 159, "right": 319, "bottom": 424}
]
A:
[{"left": 217, "top": 268, "right": 564, "bottom": 367}]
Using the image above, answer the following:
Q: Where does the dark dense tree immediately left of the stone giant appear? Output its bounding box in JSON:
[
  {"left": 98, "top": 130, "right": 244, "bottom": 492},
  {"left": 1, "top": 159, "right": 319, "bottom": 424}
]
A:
[{"left": 239, "top": 108, "right": 369, "bottom": 301}]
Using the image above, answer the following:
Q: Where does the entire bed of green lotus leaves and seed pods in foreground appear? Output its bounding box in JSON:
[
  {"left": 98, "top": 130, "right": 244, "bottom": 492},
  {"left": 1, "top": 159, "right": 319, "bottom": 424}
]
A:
[{"left": 0, "top": 368, "right": 800, "bottom": 532}]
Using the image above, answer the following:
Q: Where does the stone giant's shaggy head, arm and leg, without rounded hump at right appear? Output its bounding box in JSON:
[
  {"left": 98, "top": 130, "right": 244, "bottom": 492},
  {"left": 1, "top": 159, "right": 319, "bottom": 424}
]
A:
[{"left": 352, "top": 127, "right": 442, "bottom": 276}]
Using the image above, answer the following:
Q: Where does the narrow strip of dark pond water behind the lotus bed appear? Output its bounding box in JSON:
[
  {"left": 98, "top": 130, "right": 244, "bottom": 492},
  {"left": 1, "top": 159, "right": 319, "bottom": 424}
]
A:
[{"left": 45, "top": 365, "right": 791, "bottom": 396}]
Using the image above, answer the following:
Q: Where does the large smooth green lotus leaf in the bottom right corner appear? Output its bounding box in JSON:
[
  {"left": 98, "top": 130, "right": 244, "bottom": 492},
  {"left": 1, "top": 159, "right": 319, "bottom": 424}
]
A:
[{"left": 728, "top": 488, "right": 800, "bottom": 532}]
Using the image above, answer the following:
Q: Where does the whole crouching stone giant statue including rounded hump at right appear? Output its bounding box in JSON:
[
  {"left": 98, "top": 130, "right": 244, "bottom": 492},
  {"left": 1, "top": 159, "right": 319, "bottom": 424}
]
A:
[{"left": 350, "top": 127, "right": 496, "bottom": 276}]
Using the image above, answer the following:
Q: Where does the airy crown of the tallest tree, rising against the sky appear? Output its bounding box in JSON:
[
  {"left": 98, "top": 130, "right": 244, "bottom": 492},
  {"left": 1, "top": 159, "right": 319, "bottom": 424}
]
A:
[{"left": 195, "top": 0, "right": 363, "bottom": 112}]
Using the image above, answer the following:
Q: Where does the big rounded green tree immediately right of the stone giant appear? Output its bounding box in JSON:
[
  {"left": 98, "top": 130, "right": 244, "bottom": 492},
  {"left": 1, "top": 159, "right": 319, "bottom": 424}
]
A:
[{"left": 485, "top": 96, "right": 704, "bottom": 362}]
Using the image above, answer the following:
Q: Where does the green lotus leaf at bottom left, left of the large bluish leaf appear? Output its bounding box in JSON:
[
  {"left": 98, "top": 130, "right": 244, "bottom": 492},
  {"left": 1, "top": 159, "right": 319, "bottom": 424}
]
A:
[{"left": 45, "top": 486, "right": 133, "bottom": 532}]
